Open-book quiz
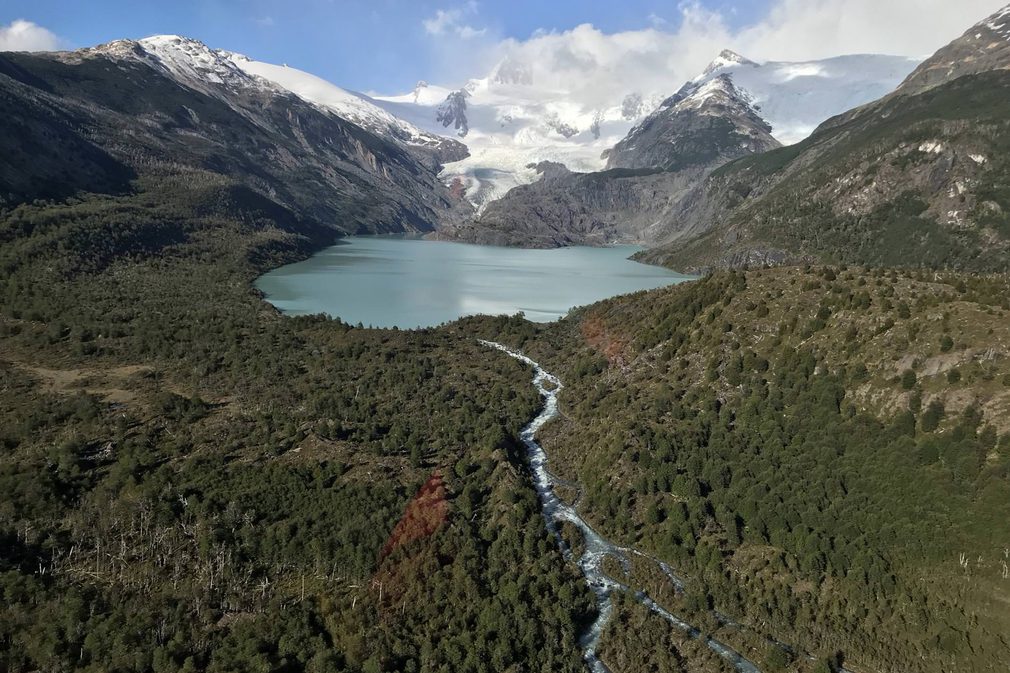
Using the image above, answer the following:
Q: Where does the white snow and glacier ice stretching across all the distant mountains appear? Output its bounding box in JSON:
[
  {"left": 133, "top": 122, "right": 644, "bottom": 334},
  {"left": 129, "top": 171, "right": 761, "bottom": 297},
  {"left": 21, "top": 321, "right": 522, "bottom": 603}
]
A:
[{"left": 67, "top": 35, "right": 916, "bottom": 217}]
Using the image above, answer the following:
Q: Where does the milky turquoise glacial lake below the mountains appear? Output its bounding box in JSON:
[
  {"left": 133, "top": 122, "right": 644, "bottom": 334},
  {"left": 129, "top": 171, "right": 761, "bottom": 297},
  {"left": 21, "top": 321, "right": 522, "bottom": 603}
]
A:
[{"left": 256, "top": 236, "right": 691, "bottom": 328}]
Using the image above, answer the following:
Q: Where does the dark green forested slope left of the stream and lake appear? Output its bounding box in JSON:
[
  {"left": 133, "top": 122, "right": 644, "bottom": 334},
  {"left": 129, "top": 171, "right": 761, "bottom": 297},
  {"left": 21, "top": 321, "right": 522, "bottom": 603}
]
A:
[{"left": 0, "top": 178, "right": 592, "bottom": 672}]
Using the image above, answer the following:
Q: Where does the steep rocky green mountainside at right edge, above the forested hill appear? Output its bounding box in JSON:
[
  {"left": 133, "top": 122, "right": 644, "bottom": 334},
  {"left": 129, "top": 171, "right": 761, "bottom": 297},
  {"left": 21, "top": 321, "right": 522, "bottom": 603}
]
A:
[{"left": 639, "top": 2, "right": 1010, "bottom": 271}]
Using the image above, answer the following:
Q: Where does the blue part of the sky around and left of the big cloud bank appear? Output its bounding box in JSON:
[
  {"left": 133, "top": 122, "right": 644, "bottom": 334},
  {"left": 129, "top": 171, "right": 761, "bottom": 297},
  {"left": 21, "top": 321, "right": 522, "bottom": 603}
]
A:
[{"left": 0, "top": 0, "right": 765, "bottom": 91}]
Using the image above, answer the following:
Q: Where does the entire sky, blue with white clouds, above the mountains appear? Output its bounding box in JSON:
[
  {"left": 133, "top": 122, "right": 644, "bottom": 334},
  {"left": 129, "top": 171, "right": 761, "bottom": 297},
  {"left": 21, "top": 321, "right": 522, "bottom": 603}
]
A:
[{"left": 0, "top": 0, "right": 1006, "bottom": 94}]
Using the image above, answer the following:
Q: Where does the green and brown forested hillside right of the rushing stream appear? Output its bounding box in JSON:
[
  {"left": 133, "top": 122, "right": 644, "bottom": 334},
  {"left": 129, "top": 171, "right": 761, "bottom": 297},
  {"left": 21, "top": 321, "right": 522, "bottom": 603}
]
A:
[{"left": 480, "top": 267, "right": 1010, "bottom": 671}]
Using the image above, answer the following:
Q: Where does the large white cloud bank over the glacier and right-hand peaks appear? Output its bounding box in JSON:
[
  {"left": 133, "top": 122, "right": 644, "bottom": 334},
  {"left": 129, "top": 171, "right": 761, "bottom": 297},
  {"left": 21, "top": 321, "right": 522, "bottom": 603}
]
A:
[{"left": 416, "top": 0, "right": 1006, "bottom": 106}]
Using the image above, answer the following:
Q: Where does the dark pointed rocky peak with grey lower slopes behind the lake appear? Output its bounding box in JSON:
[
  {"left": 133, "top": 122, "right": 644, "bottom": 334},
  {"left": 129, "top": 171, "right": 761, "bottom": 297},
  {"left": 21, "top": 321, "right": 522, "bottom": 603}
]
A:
[{"left": 439, "top": 65, "right": 781, "bottom": 247}]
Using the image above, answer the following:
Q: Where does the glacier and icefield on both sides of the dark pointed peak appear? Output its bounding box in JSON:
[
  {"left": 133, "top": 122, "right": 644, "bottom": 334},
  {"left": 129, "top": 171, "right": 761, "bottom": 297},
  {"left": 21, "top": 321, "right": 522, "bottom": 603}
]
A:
[{"left": 372, "top": 51, "right": 918, "bottom": 210}]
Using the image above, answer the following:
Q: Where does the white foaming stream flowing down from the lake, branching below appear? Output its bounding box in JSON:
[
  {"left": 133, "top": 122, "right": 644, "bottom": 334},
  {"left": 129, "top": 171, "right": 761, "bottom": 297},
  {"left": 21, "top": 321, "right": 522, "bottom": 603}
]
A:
[{"left": 481, "top": 340, "right": 761, "bottom": 673}]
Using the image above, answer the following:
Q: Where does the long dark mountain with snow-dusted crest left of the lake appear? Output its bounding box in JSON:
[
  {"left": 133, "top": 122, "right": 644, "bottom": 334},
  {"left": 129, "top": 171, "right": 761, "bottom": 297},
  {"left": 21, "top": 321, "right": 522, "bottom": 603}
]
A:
[{"left": 28, "top": 35, "right": 473, "bottom": 232}]
